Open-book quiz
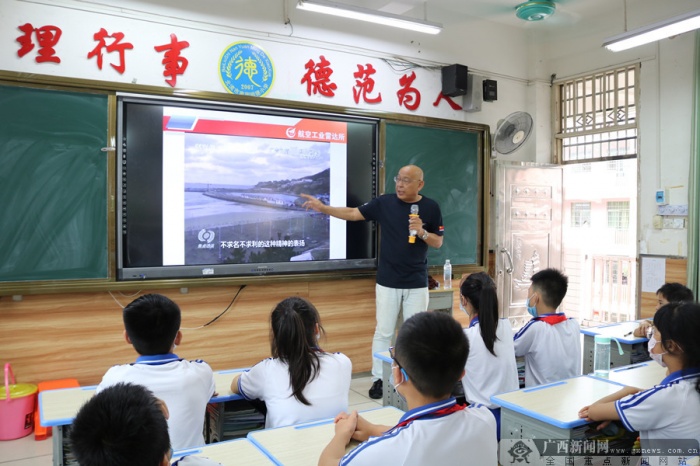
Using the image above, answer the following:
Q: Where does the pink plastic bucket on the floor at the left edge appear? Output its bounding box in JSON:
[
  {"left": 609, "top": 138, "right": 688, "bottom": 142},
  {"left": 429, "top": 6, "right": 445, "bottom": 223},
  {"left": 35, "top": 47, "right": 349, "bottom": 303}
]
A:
[{"left": 0, "top": 363, "right": 37, "bottom": 440}]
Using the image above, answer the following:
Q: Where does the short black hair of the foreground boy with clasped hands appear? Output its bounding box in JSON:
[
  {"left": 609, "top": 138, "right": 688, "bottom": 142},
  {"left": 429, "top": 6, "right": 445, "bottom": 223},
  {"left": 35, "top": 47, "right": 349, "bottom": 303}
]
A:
[{"left": 394, "top": 311, "right": 469, "bottom": 398}]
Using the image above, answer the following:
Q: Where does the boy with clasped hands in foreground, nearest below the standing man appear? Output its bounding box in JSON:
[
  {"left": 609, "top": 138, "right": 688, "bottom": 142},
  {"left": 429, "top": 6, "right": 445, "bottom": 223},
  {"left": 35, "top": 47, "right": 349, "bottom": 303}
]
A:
[{"left": 318, "top": 312, "right": 497, "bottom": 466}]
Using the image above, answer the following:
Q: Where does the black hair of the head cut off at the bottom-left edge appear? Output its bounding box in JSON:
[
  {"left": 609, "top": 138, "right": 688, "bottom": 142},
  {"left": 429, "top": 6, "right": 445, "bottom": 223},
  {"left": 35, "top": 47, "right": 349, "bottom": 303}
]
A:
[{"left": 70, "top": 383, "right": 170, "bottom": 466}]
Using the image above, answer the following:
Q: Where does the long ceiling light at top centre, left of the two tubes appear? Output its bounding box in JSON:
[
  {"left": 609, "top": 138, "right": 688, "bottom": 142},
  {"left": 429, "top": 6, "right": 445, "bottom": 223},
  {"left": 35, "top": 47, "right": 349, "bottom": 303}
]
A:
[{"left": 297, "top": 0, "right": 442, "bottom": 34}]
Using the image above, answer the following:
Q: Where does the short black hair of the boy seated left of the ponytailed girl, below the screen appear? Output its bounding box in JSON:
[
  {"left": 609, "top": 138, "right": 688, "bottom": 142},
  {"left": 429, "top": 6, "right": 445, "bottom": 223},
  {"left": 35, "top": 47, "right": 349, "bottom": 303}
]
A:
[{"left": 122, "top": 294, "right": 180, "bottom": 356}]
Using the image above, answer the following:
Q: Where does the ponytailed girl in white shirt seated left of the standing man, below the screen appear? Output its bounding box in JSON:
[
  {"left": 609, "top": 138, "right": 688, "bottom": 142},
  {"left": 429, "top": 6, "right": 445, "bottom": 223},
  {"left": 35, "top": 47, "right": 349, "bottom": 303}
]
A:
[{"left": 231, "top": 297, "right": 352, "bottom": 428}]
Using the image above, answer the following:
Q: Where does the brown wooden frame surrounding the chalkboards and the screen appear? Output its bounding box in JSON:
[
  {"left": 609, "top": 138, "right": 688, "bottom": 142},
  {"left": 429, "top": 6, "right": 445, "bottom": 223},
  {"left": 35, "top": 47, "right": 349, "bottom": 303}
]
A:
[{"left": 0, "top": 70, "right": 490, "bottom": 299}]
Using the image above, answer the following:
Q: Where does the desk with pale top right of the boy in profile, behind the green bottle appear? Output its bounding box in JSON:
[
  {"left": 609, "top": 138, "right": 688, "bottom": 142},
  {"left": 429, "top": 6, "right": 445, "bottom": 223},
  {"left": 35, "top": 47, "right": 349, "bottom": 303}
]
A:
[{"left": 581, "top": 320, "right": 650, "bottom": 374}]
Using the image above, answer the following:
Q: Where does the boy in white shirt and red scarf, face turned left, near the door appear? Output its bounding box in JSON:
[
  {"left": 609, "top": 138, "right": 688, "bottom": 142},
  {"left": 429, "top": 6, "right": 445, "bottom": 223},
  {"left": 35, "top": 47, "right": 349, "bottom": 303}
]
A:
[{"left": 514, "top": 269, "right": 581, "bottom": 387}]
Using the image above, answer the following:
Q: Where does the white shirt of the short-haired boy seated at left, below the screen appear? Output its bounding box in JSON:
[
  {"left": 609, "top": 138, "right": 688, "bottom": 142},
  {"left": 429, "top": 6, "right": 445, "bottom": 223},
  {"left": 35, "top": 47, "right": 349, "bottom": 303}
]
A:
[{"left": 96, "top": 353, "right": 216, "bottom": 450}]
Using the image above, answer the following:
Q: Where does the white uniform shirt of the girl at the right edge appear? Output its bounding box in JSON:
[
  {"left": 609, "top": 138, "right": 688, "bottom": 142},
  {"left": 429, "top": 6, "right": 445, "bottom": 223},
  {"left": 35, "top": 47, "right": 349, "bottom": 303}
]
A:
[{"left": 615, "top": 367, "right": 700, "bottom": 448}]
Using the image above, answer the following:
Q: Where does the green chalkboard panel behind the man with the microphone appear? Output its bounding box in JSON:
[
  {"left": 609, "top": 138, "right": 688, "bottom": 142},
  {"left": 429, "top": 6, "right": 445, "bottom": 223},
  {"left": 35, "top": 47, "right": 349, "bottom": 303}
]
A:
[{"left": 384, "top": 123, "right": 484, "bottom": 266}]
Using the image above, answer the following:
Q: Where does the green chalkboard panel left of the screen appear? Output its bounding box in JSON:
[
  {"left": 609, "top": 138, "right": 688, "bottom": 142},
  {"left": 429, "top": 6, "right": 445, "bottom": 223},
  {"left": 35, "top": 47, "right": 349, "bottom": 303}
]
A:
[{"left": 0, "top": 86, "right": 108, "bottom": 282}]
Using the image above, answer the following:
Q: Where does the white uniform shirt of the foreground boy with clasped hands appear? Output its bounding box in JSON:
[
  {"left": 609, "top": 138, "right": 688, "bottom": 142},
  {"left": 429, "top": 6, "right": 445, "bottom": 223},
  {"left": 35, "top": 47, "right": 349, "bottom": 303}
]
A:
[{"left": 340, "top": 398, "right": 498, "bottom": 466}]
